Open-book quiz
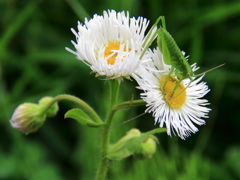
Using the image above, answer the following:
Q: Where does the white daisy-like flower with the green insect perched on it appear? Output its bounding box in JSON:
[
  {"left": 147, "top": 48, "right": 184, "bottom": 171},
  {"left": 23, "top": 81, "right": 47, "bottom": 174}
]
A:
[{"left": 133, "top": 49, "right": 211, "bottom": 139}]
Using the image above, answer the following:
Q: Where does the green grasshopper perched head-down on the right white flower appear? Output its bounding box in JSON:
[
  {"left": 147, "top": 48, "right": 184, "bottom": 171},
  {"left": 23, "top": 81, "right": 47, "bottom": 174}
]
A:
[{"left": 157, "top": 16, "right": 224, "bottom": 94}]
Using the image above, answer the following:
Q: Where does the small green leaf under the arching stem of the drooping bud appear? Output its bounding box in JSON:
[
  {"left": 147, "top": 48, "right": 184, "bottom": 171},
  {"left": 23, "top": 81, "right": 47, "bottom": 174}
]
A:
[{"left": 64, "top": 108, "right": 103, "bottom": 127}]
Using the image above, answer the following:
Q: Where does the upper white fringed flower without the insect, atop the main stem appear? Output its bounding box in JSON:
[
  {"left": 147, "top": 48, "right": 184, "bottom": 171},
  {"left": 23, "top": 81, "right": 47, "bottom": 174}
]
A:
[{"left": 66, "top": 10, "right": 153, "bottom": 79}]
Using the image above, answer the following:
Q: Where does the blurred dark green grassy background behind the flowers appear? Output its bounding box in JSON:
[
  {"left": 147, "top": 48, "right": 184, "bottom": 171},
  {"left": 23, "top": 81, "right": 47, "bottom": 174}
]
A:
[{"left": 0, "top": 0, "right": 240, "bottom": 180}]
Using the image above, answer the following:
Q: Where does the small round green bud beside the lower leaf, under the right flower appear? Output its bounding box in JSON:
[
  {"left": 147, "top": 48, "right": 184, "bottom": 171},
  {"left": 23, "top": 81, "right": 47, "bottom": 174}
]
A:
[{"left": 135, "top": 135, "right": 158, "bottom": 159}]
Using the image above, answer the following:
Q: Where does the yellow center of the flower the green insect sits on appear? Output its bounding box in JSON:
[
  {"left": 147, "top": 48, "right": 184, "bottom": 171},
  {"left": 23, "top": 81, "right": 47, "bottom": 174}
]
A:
[{"left": 160, "top": 75, "right": 187, "bottom": 108}]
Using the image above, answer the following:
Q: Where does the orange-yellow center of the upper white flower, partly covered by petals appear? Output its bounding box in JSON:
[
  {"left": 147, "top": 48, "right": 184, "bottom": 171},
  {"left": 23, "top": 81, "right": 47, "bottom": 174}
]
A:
[{"left": 104, "top": 41, "right": 126, "bottom": 65}]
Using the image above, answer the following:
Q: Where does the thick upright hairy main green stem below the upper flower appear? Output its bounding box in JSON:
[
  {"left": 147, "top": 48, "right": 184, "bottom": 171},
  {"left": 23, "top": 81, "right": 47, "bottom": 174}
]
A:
[{"left": 96, "top": 80, "right": 119, "bottom": 180}]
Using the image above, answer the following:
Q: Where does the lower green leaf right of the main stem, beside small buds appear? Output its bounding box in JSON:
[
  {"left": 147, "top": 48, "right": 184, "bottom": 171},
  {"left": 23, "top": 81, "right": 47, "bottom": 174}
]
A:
[{"left": 106, "top": 128, "right": 166, "bottom": 160}]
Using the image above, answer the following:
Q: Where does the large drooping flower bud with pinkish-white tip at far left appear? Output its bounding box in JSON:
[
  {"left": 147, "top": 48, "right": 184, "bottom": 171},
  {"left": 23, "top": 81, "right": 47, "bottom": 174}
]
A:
[{"left": 10, "top": 103, "right": 46, "bottom": 134}]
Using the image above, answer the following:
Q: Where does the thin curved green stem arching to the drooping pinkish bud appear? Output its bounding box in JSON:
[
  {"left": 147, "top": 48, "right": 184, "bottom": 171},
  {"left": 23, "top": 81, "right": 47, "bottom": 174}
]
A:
[{"left": 42, "top": 94, "right": 102, "bottom": 123}]
